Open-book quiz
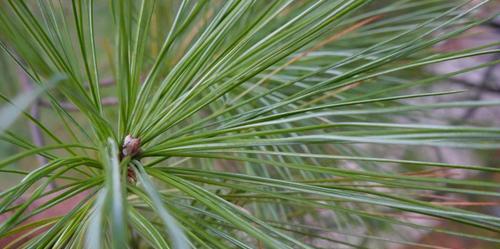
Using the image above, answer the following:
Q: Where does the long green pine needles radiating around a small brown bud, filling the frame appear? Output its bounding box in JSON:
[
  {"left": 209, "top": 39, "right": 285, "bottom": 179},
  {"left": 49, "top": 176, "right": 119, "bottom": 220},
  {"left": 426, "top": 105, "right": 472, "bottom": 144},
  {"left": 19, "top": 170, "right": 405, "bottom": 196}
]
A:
[{"left": 0, "top": 0, "right": 500, "bottom": 248}]
